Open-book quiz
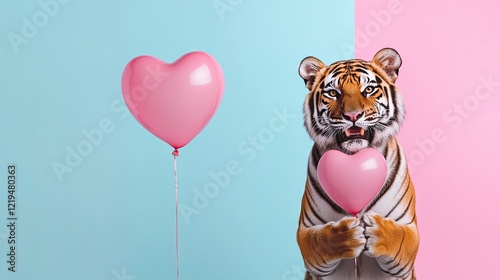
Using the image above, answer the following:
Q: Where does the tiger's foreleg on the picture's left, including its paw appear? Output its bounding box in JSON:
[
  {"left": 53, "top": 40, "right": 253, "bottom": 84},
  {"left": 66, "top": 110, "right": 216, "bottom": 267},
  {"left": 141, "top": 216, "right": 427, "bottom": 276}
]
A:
[{"left": 297, "top": 217, "right": 366, "bottom": 276}]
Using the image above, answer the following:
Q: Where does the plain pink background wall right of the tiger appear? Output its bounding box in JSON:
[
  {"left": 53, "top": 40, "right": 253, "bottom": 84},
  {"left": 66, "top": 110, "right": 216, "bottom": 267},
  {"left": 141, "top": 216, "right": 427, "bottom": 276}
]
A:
[{"left": 356, "top": 0, "right": 500, "bottom": 280}]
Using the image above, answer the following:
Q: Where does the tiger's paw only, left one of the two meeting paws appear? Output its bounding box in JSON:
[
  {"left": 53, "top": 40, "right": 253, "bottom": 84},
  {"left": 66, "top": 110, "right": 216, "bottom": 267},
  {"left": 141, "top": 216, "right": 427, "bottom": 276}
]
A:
[{"left": 322, "top": 217, "right": 366, "bottom": 259}]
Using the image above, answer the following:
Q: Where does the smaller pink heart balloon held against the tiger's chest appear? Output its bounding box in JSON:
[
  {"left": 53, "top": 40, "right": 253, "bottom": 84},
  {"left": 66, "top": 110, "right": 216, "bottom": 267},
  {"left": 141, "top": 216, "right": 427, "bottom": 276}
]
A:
[{"left": 318, "top": 148, "right": 387, "bottom": 215}]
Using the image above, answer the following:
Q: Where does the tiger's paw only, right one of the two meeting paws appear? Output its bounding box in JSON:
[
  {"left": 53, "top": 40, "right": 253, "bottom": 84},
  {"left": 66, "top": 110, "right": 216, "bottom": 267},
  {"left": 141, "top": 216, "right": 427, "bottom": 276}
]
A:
[{"left": 363, "top": 212, "right": 404, "bottom": 258}]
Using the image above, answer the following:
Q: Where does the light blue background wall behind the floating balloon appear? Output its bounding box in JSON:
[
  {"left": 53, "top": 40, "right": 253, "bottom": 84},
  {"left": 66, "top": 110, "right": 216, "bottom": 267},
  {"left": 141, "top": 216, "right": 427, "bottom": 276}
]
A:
[{"left": 0, "top": 0, "right": 354, "bottom": 280}]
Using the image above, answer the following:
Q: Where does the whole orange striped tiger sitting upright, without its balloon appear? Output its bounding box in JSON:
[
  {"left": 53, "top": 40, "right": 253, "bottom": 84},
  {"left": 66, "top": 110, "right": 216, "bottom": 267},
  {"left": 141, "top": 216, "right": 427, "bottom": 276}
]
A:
[{"left": 297, "top": 48, "right": 420, "bottom": 280}]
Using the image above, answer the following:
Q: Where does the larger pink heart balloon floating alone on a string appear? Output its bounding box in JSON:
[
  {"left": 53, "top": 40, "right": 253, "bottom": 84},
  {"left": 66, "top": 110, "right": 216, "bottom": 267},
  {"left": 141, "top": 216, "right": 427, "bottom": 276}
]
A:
[{"left": 122, "top": 52, "right": 224, "bottom": 149}]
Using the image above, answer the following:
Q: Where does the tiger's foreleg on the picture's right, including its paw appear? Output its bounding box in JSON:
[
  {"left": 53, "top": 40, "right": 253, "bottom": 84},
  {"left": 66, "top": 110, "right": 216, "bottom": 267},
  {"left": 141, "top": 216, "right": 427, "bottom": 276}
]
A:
[{"left": 363, "top": 212, "right": 419, "bottom": 280}]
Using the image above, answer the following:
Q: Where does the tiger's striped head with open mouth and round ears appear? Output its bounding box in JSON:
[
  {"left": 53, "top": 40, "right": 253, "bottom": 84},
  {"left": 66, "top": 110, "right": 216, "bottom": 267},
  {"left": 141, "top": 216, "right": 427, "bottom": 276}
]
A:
[{"left": 299, "top": 48, "right": 405, "bottom": 154}]
